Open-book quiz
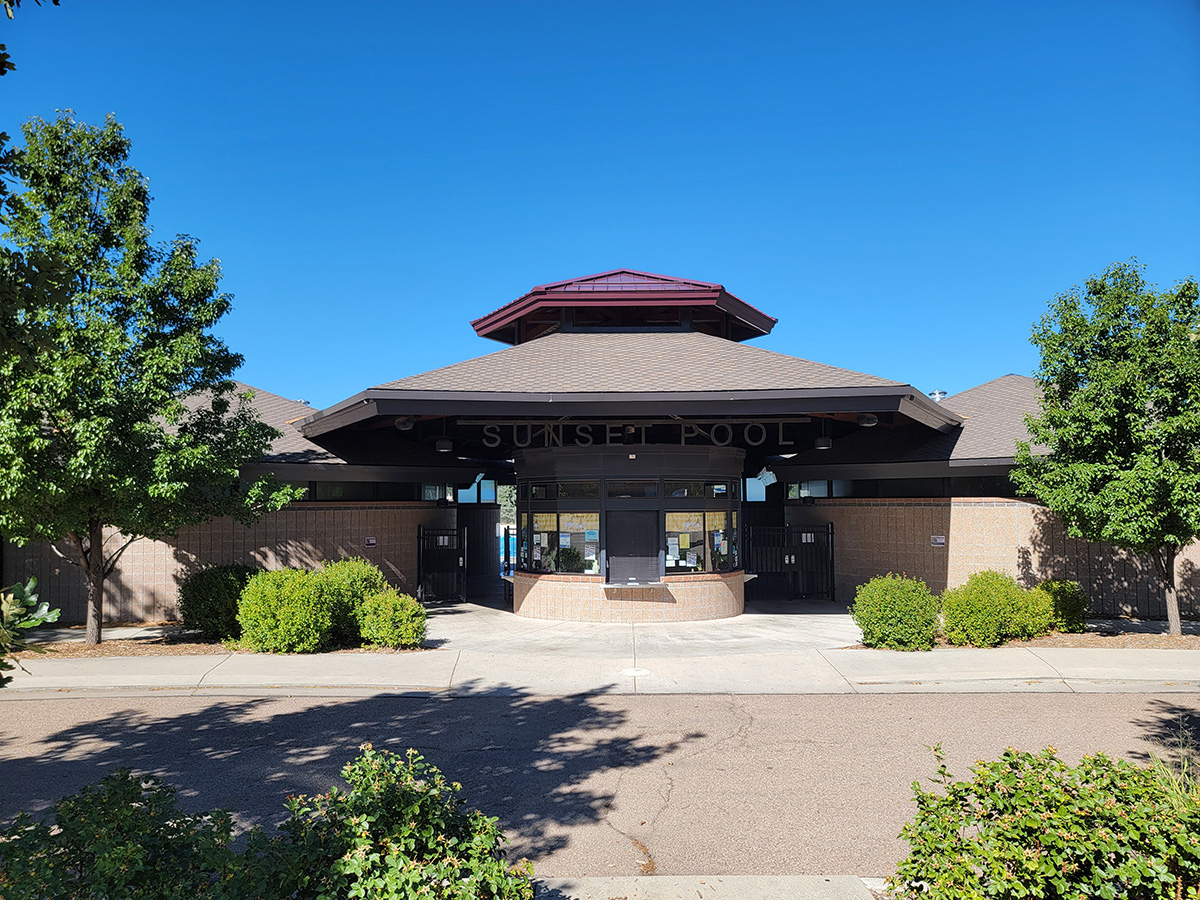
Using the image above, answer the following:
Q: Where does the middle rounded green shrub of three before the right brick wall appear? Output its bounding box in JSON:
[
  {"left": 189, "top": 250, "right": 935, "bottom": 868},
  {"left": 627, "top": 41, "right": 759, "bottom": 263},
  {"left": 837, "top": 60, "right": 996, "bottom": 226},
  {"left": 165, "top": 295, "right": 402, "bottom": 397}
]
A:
[{"left": 942, "top": 571, "right": 1054, "bottom": 647}]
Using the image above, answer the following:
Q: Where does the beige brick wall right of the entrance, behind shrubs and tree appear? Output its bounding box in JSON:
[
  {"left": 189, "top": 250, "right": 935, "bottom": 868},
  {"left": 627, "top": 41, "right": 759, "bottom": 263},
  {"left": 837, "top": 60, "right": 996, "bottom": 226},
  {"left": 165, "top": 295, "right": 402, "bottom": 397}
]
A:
[{"left": 787, "top": 498, "right": 1200, "bottom": 618}]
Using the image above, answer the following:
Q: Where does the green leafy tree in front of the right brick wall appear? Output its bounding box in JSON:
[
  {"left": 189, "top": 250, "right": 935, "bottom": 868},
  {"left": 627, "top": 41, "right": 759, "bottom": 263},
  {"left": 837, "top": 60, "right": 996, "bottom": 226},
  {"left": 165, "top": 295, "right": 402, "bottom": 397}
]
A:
[{"left": 1013, "top": 260, "right": 1200, "bottom": 635}]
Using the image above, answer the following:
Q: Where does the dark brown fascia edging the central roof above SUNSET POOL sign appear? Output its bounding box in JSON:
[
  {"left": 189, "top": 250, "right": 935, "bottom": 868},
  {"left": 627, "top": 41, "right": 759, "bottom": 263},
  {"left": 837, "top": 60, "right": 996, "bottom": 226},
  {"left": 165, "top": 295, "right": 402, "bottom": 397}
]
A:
[{"left": 301, "top": 385, "right": 962, "bottom": 438}]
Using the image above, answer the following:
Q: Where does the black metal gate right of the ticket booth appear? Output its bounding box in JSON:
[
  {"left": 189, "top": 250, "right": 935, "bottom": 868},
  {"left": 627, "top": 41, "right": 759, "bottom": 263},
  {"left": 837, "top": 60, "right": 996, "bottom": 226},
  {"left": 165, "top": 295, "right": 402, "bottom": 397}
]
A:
[{"left": 743, "top": 522, "right": 835, "bottom": 600}]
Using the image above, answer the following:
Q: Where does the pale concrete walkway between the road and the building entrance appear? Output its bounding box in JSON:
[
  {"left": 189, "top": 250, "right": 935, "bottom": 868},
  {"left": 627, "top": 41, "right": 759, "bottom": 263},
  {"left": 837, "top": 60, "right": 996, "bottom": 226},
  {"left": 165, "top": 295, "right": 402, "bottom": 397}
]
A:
[{"left": 9, "top": 602, "right": 1200, "bottom": 700}]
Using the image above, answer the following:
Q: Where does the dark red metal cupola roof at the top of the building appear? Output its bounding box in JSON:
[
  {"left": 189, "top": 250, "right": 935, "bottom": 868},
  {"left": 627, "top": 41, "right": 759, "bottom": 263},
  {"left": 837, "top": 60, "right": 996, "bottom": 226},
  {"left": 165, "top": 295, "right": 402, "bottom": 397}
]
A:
[{"left": 470, "top": 269, "right": 776, "bottom": 344}]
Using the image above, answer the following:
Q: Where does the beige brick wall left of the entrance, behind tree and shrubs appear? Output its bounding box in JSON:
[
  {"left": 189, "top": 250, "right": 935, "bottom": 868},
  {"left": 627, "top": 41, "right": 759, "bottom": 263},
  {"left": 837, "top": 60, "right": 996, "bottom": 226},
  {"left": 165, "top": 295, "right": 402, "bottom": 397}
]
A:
[{"left": 2, "top": 503, "right": 455, "bottom": 623}]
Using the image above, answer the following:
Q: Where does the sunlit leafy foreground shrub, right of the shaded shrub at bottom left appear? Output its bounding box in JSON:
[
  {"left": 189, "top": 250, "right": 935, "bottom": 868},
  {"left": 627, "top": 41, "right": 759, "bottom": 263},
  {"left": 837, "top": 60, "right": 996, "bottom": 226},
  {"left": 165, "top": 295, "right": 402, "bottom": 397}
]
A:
[{"left": 262, "top": 744, "right": 533, "bottom": 900}]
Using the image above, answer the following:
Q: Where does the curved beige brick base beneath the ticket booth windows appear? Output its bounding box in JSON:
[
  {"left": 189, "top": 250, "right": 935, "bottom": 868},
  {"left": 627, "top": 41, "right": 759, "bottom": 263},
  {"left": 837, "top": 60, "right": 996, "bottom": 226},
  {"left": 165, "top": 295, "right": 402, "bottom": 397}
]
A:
[{"left": 512, "top": 571, "right": 745, "bottom": 622}]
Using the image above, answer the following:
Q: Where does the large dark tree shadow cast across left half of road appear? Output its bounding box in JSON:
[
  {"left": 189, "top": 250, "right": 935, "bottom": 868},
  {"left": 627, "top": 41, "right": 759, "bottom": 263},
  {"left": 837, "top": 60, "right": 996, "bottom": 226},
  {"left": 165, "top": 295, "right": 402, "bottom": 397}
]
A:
[{"left": 0, "top": 685, "right": 704, "bottom": 857}]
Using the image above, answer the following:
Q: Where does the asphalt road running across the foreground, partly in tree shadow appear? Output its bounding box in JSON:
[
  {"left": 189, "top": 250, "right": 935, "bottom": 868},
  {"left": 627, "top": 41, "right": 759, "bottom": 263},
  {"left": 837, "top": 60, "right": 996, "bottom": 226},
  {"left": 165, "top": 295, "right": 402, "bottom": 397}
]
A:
[{"left": 0, "top": 694, "right": 1200, "bottom": 877}]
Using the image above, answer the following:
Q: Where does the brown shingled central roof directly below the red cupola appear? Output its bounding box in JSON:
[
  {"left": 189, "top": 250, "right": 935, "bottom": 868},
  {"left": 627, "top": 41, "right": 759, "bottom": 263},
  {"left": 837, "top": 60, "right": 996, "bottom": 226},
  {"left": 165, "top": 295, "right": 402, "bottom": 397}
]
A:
[{"left": 378, "top": 331, "right": 900, "bottom": 394}]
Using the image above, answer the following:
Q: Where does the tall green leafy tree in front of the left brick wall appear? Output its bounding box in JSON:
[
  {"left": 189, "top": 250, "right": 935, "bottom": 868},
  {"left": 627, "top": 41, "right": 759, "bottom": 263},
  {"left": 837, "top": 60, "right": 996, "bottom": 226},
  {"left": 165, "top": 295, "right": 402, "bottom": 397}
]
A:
[{"left": 0, "top": 113, "right": 299, "bottom": 643}]
